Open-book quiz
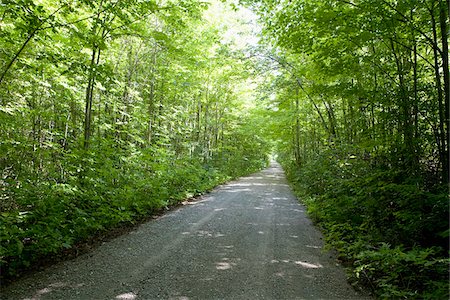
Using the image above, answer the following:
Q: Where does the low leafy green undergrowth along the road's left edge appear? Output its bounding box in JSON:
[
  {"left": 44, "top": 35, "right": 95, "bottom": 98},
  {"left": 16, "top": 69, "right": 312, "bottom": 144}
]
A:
[{"left": 0, "top": 146, "right": 266, "bottom": 281}]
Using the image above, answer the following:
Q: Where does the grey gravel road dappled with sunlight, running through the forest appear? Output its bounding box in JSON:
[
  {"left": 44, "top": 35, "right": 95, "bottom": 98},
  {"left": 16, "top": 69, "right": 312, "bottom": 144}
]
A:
[{"left": 1, "top": 163, "right": 369, "bottom": 300}]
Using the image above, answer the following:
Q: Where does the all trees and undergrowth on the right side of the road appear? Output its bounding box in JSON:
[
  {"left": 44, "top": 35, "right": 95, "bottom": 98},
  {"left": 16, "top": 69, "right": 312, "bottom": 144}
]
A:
[{"left": 248, "top": 0, "right": 450, "bottom": 299}]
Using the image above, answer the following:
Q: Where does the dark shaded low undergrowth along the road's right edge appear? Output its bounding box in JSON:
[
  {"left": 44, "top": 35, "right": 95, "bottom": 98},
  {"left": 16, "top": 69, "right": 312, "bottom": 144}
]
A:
[{"left": 283, "top": 150, "right": 449, "bottom": 299}]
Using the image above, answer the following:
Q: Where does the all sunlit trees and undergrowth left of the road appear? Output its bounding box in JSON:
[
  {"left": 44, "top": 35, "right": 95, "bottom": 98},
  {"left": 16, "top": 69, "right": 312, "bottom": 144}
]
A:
[{"left": 0, "top": 0, "right": 269, "bottom": 279}]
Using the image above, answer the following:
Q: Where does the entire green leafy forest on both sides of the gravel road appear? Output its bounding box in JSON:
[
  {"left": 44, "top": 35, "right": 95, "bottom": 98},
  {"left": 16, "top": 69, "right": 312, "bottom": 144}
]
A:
[{"left": 0, "top": 0, "right": 450, "bottom": 299}]
